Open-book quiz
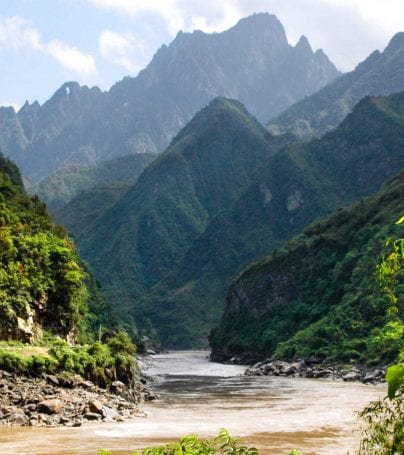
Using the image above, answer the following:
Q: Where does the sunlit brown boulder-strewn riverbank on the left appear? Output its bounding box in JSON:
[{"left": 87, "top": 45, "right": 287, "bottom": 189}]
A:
[{"left": 0, "top": 370, "right": 157, "bottom": 427}]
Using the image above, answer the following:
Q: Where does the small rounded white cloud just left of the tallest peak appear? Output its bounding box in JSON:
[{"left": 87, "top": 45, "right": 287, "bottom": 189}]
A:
[{"left": 99, "top": 30, "right": 148, "bottom": 73}]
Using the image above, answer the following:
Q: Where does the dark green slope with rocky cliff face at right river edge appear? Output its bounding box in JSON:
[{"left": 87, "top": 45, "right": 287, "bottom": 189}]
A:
[{"left": 211, "top": 173, "right": 404, "bottom": 365}]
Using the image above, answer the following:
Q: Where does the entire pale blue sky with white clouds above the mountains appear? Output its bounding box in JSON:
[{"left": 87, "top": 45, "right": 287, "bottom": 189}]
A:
[{"left": 0, "top": 0, "right": 404, "bottom": 108}]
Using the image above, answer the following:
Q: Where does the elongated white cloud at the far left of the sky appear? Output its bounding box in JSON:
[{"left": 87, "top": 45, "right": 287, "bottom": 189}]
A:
[{"left": 0, "top": 16, "right": 96, "bottom": 76}]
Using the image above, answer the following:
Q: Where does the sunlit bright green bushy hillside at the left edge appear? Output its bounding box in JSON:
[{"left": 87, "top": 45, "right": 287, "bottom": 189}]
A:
[{"left": 0, "top": 154, "right": 111, "bottom": 342}]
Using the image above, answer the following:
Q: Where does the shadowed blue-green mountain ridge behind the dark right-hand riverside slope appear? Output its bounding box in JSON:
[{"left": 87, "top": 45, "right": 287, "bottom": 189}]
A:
[{"left": 137, "top": 92, "right": 404, "bottom": 348}]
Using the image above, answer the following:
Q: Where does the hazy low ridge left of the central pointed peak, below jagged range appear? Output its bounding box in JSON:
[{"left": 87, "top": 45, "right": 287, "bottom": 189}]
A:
[{"left": 29, "top": 153, "right": 156, "bottom": 213}]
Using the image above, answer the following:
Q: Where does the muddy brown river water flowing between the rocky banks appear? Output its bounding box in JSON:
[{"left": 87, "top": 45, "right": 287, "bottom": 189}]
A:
[{"left": 0, "top": 351, "right": 385, "bottom": 455}]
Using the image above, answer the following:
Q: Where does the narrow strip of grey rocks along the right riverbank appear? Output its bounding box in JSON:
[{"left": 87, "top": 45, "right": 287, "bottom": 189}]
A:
[{"left": 245, "top": 359, "right": 385, "bottom": 384}]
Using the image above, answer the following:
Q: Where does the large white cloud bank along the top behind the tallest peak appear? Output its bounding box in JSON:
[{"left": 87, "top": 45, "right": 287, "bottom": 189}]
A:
[{"left": 86, "top": 0, "right": 404, "bottom": 70}]
